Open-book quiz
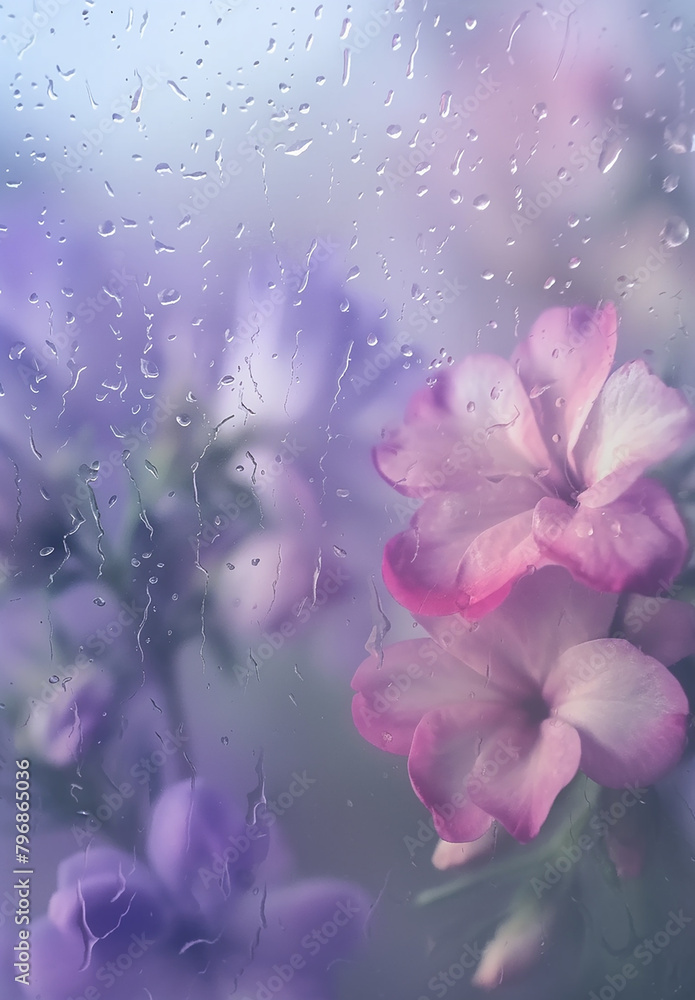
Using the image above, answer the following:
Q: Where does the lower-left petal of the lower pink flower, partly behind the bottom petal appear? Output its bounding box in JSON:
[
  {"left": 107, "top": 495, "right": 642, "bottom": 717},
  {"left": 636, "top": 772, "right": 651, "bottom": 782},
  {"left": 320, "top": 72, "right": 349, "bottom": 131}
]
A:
[{"left": 408, "top": 699, "right": 509, "bottom": 842}]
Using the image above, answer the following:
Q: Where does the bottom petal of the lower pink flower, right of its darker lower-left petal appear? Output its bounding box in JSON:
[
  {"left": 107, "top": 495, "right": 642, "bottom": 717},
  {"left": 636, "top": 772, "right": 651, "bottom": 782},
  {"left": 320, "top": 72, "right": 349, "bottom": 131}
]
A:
[{"left": 468, "top": 719, "right": 581, "bottom": 844}]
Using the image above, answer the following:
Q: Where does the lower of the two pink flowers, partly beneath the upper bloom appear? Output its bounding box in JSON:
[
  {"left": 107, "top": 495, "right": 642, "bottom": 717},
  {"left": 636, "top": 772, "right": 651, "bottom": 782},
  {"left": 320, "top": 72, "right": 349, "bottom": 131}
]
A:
[{"left": 353, "top": 568, "right": 692, "bottom": 842}]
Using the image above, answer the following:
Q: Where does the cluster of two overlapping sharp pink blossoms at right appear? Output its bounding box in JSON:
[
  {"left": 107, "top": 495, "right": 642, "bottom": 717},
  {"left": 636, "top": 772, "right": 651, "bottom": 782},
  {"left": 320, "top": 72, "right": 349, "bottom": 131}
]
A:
[{"left": 353, "top": 304, "right": 695, "bottom": 860}]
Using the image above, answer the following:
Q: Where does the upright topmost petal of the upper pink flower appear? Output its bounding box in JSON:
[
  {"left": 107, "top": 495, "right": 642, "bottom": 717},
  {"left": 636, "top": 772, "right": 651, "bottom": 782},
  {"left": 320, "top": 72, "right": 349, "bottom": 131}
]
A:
[{"left": 511, "top": 302, "right": 618, "bottom": 471}]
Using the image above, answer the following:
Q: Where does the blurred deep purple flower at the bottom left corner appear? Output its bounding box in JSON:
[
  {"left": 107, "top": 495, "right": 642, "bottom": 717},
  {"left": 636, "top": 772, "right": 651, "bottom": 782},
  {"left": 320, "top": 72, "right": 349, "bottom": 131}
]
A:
[{"left": 32, "top": 781, "right": 369, "bottom": 1000}]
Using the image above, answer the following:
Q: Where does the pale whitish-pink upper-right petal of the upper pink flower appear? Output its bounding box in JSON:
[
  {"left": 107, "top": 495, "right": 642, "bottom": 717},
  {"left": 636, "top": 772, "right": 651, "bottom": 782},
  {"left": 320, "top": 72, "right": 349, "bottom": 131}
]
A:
[{"left": 575, "top": 361, "right": 695, "bottom": 507}]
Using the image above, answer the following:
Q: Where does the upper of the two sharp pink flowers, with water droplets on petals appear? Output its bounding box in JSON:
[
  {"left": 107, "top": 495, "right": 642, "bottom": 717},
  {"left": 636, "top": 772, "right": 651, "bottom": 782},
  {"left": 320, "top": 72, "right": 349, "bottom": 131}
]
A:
[{"left": 375, "top": 304, "right": 695, "bottom": 618}]
